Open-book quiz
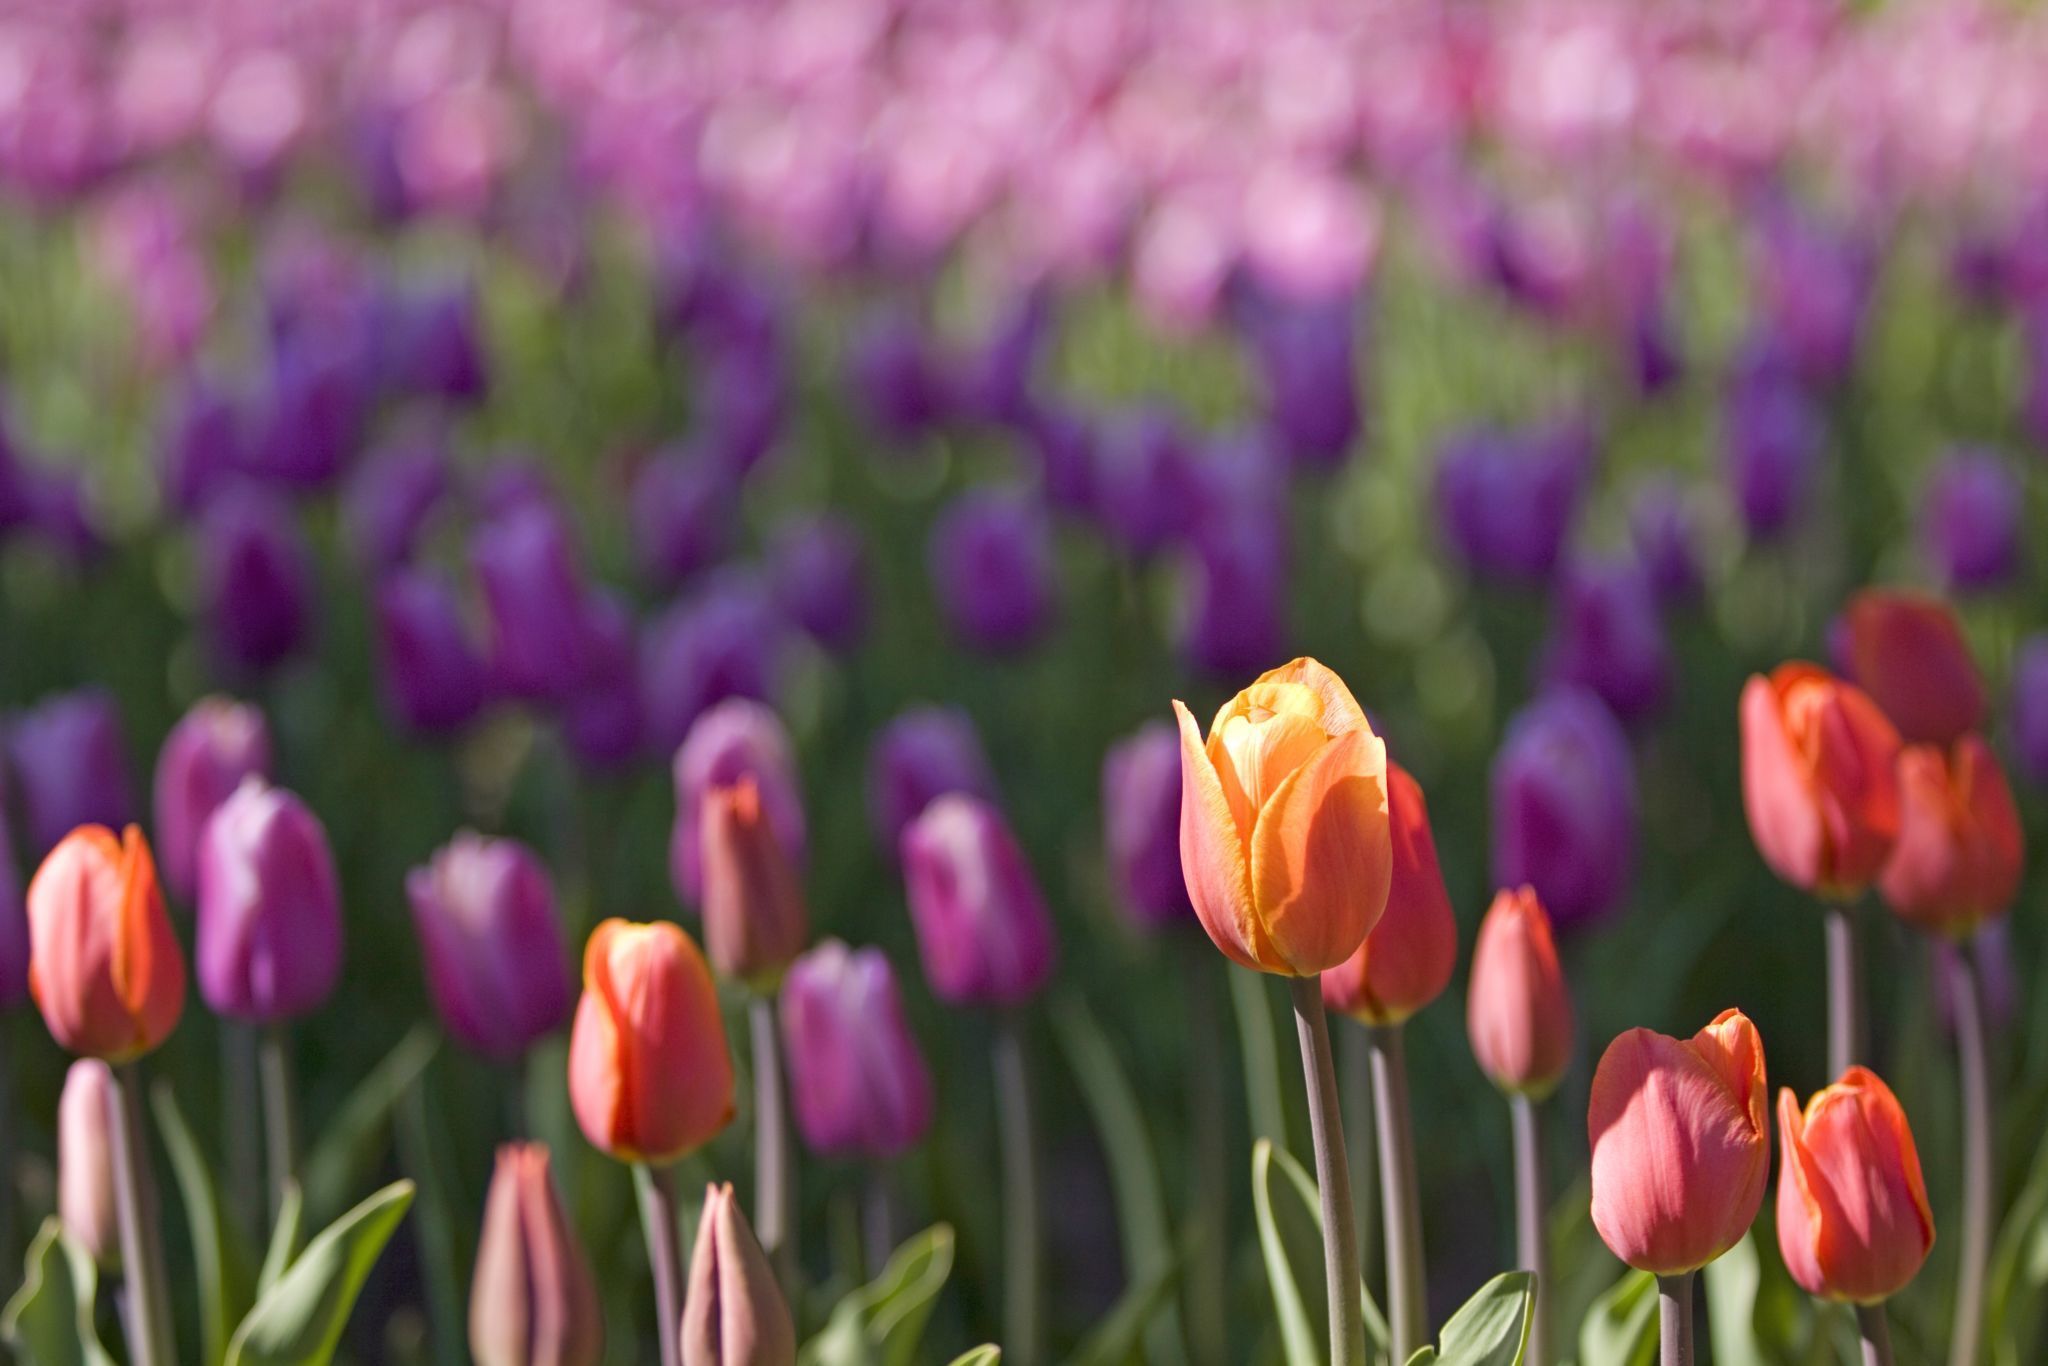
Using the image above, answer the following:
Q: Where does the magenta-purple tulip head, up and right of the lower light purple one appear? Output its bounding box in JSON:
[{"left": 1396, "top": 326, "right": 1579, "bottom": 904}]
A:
[{"left": 901, "top": 793, "right": 1055, "bottom": 1006}]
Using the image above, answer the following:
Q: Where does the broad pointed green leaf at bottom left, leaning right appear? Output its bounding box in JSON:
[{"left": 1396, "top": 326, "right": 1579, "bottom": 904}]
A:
[{"left": 227, "top": 1182, "right": 412, "bottom": 1366}]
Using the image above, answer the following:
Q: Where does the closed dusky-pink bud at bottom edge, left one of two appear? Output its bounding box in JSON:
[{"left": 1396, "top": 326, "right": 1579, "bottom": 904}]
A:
[{"left": 469, "top": 1143, "right": 604, "bottom": 1366}]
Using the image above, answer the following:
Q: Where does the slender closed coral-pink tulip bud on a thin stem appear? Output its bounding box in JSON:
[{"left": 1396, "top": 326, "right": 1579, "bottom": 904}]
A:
[{"left": 1464, "top": 887, "right": 1573, "bottom": 1098}]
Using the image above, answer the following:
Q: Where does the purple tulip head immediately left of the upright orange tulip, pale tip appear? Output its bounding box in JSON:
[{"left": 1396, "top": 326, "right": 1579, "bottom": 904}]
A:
[{"left": 406, "top": 829, "right": 573, "bottom": 1061}]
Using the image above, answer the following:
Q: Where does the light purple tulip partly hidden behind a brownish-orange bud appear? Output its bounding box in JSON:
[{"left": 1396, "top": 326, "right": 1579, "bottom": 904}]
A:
[{"left": 668, "top": 696, "right": 805, "bottom": 905}]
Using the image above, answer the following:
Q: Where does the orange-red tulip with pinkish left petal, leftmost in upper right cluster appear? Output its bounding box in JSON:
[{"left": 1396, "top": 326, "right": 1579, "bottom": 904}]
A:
[{"left": 1743, "top": 661, "right": 1898, "bottom": 901}]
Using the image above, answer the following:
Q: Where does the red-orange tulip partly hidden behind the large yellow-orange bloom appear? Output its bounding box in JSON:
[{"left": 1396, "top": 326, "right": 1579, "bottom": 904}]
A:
[{"left": 1323, "top": 760, "right": 1458, "bottom": 1024}]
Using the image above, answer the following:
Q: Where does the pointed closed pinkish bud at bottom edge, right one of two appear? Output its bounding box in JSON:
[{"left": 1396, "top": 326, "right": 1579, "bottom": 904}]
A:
[{"left": 682, "top": 1184, "right": 797, "bottom": 1366}]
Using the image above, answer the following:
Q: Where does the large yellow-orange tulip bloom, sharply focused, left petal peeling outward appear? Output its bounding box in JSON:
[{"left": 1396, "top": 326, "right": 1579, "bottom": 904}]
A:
[{"left": 1174, "top": 659, "right": 1393, "bottom": 977}]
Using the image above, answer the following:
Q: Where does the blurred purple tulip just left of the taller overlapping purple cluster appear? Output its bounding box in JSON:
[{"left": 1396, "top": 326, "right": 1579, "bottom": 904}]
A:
[{"left": 377, "top": 569, "right": 489, "bottom": 731}]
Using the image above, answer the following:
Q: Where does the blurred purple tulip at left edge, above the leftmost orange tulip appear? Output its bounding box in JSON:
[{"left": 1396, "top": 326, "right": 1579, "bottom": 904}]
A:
[{"left": 8, "top": 688, "right": 135, "bottom": 862}]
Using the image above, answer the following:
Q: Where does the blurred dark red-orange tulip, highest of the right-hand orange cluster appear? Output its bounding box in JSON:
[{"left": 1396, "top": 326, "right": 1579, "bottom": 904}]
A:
[{"left": 1841, "top": 588, "right": 1985, "bottom": 745}]
